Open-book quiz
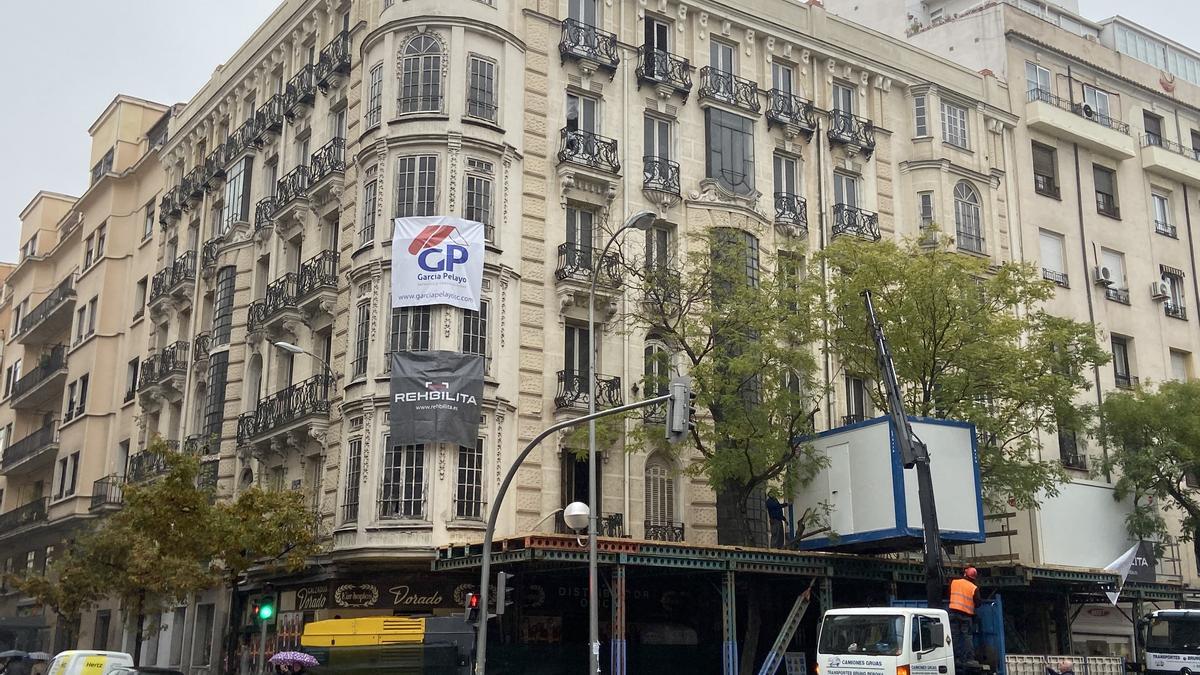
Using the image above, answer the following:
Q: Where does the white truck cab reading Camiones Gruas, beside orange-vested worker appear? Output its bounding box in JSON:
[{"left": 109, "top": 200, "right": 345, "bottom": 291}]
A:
[{"left": 817, "top": 607, "right": 954, "bottom": 675}]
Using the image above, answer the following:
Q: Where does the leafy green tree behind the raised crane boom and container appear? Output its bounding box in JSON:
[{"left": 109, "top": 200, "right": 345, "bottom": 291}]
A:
[{"left": 808, "top": 238, "right": 1108, "bottom": 508}]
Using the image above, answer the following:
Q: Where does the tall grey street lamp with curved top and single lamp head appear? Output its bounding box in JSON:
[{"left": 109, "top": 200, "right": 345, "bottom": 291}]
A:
[{"left": 588, "top": 211, "right": 658, "bottom": 675}]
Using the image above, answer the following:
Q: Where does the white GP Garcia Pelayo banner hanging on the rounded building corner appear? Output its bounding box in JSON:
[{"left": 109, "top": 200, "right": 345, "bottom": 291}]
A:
[{"left": 391, "top": 216, "right": 484, "bottom": 311}]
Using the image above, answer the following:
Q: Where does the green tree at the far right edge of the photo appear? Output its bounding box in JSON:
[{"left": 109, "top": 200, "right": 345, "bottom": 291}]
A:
[{"left": 1100, "top": 380, "right": 1200, "bottom": 560}]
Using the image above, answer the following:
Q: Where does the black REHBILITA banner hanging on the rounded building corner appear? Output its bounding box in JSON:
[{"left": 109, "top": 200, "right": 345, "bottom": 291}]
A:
[{"left": 391, "top": 352, "right": 485, "bottom": 446}]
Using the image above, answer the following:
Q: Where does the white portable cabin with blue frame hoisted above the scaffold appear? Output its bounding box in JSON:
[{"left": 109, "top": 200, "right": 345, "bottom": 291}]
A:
[{"left": 792, "top": 417, "right": 984, "bottom": 552}]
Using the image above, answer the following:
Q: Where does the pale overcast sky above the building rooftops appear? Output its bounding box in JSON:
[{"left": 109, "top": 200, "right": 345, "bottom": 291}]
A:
[{"left": 0, "top": 0, "right": 1200, "bottom": 261}]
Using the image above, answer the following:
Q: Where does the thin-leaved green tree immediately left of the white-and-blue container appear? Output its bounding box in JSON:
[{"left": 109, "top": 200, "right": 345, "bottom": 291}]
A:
[{"left": 609, "top": 228, "right": 822, "bottom": 545}]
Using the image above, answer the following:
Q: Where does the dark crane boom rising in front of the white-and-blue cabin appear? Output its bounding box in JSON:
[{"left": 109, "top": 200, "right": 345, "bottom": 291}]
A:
[{"left": 863, "top": 291, "right": 944, "bottom": 608}]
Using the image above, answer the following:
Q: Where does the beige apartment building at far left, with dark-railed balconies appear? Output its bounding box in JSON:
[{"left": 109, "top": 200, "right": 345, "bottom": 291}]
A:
[{"left": 0, "top": 95, "right": 169, "bottom": 649}]
